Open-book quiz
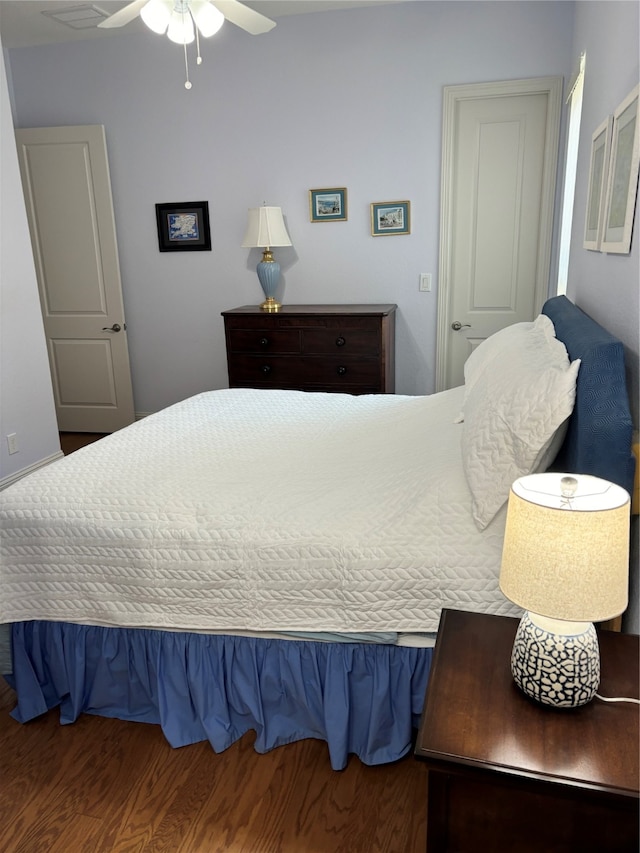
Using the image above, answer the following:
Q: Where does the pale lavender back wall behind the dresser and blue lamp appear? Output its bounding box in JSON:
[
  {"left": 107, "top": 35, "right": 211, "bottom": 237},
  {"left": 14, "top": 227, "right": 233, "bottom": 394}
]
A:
[{"left": 8, "top": 2, "right": 574, "bottom": 412}]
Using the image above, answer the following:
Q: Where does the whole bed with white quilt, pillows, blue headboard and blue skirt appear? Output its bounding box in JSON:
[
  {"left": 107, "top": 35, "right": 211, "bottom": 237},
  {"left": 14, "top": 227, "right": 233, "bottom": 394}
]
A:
[{"left": 0, "top": 297, "right": 634, "bottom": 769}]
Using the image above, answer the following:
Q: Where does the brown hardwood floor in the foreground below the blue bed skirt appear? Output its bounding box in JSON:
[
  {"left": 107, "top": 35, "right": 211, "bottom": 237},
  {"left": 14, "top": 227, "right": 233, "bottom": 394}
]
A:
[{"left": 0, "top": 679, "right": 427, "bottom": 853}]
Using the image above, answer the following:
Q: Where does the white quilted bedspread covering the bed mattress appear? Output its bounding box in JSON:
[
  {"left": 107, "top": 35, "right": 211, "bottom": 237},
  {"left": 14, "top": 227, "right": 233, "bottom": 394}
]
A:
[{"left": 0, "top": 389, "right": 518, "bottom": 631}]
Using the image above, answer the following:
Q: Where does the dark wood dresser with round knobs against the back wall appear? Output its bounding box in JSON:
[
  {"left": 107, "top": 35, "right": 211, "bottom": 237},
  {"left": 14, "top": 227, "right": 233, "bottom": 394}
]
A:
[{"left": 222, "top": 305, "right": 396, "bottom": 394}]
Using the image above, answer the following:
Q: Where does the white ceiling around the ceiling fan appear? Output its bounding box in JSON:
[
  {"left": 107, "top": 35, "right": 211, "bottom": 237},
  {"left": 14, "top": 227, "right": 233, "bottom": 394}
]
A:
[{"left": 0, "top": 0, "right": 399, "bottom": 47}]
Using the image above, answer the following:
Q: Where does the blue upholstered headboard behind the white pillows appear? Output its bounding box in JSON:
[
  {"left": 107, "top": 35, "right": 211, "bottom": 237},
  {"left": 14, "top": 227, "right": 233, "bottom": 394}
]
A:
[{"left": 542, "top": 296, "right": 635, "bottom": 493}]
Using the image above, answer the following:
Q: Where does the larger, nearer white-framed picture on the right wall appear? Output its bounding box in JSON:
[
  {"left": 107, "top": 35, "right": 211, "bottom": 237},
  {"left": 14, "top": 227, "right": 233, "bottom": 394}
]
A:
[{"left": 600, "top": 86, "right": 640, "bottom": 255}]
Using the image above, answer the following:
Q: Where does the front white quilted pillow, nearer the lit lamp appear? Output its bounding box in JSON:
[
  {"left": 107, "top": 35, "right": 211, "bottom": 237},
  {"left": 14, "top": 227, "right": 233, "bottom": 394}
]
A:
[{"left": 462, "top": 322, "right": 580, "bottom": 530}]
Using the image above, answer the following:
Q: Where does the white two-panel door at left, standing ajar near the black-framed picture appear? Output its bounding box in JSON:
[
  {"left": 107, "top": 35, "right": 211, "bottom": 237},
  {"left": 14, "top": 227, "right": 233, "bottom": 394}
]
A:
[{"left": 16, "top": 125, "right": 134, "bottom": 432}]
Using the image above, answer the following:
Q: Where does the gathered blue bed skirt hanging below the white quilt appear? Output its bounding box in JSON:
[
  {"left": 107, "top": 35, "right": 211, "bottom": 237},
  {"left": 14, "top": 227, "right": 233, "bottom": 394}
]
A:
[{"left": 7, "top": 622, "right": 433, "bottom": 770}]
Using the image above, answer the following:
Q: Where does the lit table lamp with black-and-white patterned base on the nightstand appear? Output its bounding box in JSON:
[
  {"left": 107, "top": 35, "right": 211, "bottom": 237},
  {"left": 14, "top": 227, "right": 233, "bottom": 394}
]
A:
[{"left": 500, "top": 473, "right": 630, "bottom": 708}]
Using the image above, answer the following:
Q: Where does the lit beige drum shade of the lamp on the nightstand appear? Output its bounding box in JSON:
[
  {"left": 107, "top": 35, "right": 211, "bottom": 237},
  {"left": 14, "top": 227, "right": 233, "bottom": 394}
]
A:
[{"left": 500, "top": 473, "right": 630, "bottom": 622}]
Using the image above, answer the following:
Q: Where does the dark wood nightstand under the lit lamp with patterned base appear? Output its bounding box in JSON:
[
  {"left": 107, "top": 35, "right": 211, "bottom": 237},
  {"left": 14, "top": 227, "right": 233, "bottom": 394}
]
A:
[{"left": 415, "top": 610, "right": 639, "bottom": 853}]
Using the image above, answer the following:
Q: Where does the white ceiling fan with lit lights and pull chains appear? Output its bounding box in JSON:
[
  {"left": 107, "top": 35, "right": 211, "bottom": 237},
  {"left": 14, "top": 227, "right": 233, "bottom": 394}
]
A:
[{"left": 98, "top": 0, "right": 276, "bottom": 89}]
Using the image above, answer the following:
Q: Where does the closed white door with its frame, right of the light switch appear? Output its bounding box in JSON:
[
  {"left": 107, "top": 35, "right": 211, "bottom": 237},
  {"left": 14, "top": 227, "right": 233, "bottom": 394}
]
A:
[{"left": 436, "top": 77, "right": 562, "bottom": 391}]
